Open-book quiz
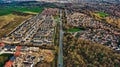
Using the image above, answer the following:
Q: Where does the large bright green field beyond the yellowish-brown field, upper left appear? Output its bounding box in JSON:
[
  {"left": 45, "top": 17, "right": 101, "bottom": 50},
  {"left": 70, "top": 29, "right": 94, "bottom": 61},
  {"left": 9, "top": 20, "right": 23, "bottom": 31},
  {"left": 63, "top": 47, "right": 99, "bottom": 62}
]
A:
[{"left": 0, "top": 6, "right": 45, "bottom": 16}]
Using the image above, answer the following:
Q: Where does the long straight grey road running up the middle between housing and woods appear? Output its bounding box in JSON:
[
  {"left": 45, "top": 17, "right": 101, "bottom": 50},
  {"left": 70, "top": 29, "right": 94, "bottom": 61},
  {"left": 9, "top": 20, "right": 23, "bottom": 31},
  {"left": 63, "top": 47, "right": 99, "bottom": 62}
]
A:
[{"left": 58, "top": 10, "right": 63, "bottom": 67}]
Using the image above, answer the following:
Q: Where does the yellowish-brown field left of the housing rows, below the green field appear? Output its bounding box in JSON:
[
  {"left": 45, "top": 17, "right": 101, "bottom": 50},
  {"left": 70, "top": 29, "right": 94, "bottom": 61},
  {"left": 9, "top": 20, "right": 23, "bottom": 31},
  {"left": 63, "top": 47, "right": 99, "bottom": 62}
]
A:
[{"left": 0, "top": 14, "right": 32, "bottom": 37}]
